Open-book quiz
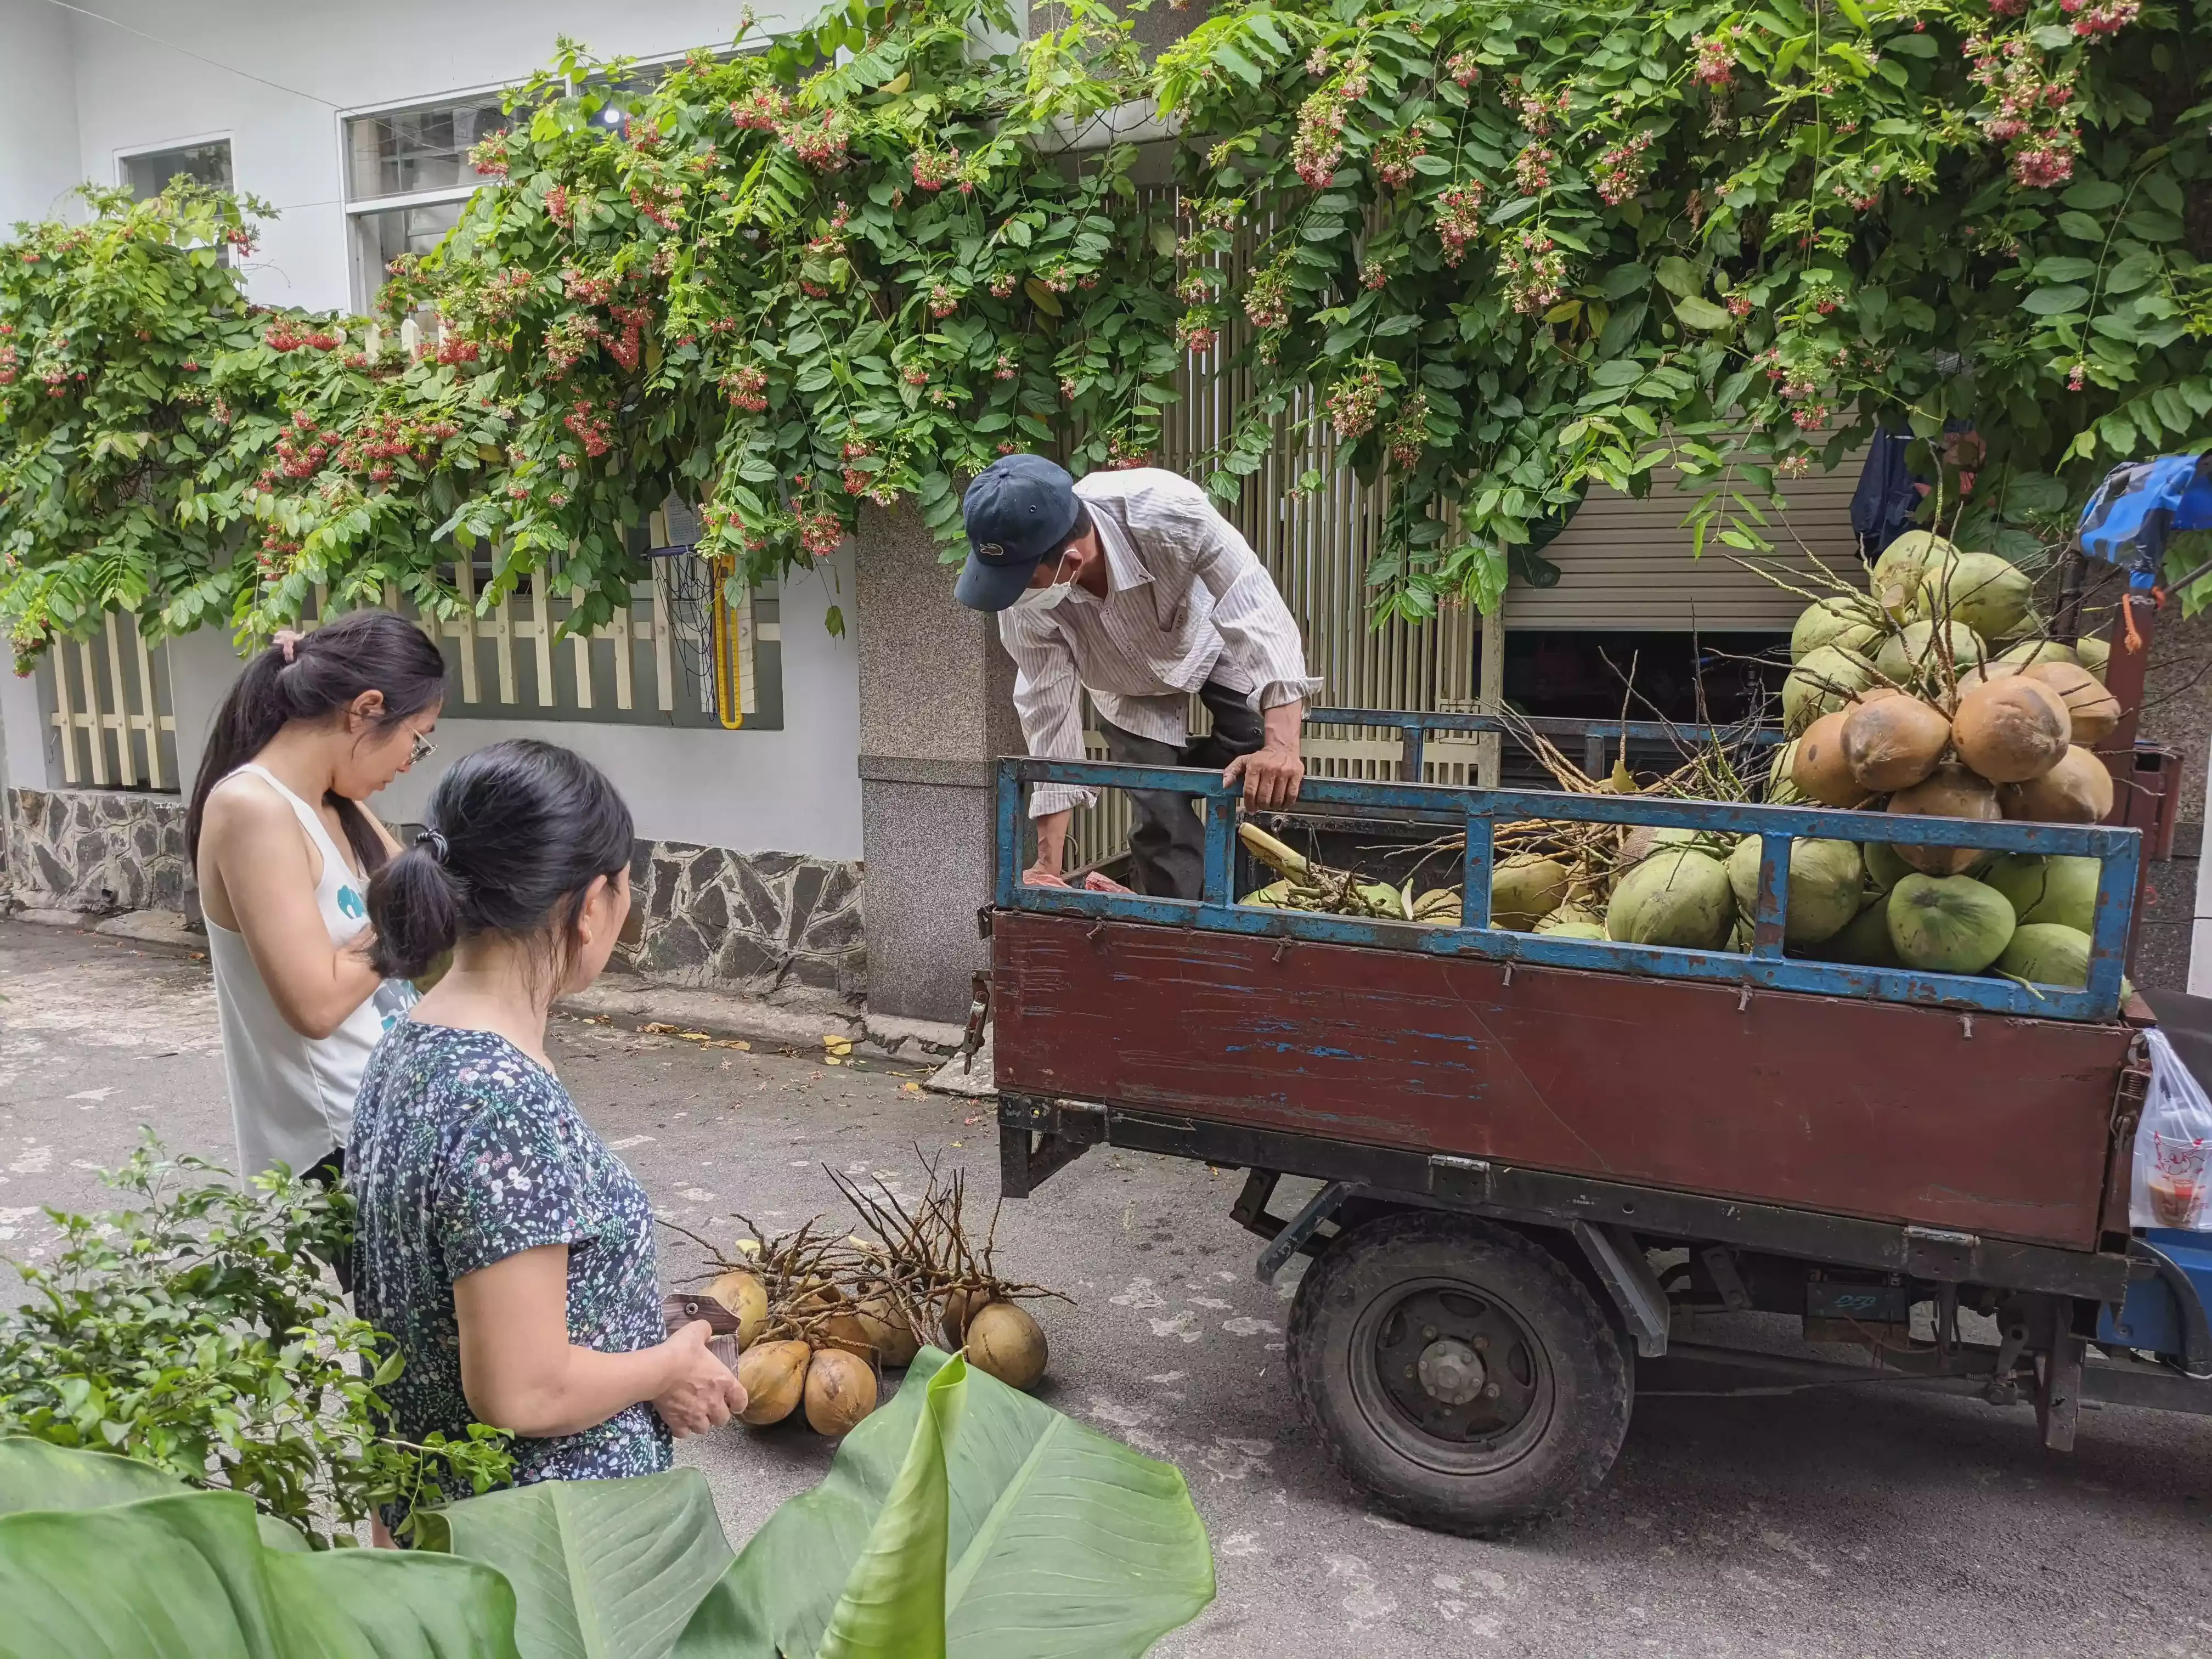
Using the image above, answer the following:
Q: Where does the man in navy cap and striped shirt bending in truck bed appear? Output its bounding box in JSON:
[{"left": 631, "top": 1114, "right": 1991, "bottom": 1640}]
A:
[{"left": 956, "top": 456, "right": 1321, "bottom": 898}]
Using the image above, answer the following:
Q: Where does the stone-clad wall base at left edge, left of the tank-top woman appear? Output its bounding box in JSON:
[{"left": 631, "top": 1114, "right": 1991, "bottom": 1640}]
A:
[{"left": 7, "top": 789, "right": 193, "bottom": 916}]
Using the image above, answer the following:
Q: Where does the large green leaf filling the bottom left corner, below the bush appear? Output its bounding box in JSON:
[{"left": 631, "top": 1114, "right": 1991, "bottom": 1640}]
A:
[{"left": 0, "top": 1486, "right": 517, "bottom": 1659}]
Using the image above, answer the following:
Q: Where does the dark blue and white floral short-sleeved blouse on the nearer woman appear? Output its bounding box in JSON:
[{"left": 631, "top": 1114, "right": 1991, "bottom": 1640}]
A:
[{"left": 345, "top": 1020, "right": 673, "bottom": 1502}]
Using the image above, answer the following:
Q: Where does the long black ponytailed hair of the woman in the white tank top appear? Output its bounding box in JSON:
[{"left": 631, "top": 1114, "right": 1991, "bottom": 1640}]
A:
[{"left": 184, "top": 611, "right": 444, "bottom": 874}]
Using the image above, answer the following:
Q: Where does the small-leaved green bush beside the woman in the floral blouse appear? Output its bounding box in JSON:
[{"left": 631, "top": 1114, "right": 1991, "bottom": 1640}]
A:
[{"left": 0, "top": 1132, "right": 513, "bottom": 1546}]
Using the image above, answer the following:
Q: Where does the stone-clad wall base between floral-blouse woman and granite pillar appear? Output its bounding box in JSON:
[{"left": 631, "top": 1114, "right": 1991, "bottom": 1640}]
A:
[{"left": 630, "top": 840, "right": 867, "bottom": 1002}]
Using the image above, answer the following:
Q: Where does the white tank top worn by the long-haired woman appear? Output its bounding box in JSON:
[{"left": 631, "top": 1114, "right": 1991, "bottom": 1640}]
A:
[{"left": 208, "top": 763, "right": 416, "bottom": 1177}]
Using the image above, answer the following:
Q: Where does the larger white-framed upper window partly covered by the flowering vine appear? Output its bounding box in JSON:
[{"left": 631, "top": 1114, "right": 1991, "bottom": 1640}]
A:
[{"left": 345, "top": 93, "right": 506, "bottom": 307}]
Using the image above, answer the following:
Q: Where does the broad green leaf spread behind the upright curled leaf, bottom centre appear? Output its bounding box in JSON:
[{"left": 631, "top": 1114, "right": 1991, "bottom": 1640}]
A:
[{"left": 677, "top": 1347, "right": 1215, "bottom": 1659}]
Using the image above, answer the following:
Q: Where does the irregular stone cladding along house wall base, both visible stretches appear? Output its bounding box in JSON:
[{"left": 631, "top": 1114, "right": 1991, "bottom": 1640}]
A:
[{"left": 4, "top": 789, "right": 867, "bottom": 1000}]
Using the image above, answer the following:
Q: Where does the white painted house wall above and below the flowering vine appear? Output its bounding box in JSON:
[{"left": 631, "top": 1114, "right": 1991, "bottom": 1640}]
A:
[{"left": 15, "top": 0, "right": 860, "bottom": 858}]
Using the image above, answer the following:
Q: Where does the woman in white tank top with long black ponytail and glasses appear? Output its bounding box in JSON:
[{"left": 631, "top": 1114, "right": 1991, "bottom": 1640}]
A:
[{"left": 184, "top": 611, "right": 444, "bottom": 1186}]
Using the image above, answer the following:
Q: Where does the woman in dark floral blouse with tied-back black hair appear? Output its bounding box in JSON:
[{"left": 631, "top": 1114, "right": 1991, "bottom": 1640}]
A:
[{"left": 347, "top": 741, "right": 746, "bottom": 1522}]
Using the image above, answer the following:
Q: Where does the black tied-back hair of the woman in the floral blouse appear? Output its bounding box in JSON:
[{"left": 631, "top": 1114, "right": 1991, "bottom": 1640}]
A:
[{"left": 369, "top": 739, "right": 630, "bottom": 980}]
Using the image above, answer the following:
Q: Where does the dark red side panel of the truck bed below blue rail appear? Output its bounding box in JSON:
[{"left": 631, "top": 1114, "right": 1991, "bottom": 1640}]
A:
[{"left": 993, "top": 911, "right": 2130, "bottom": 1250}]
